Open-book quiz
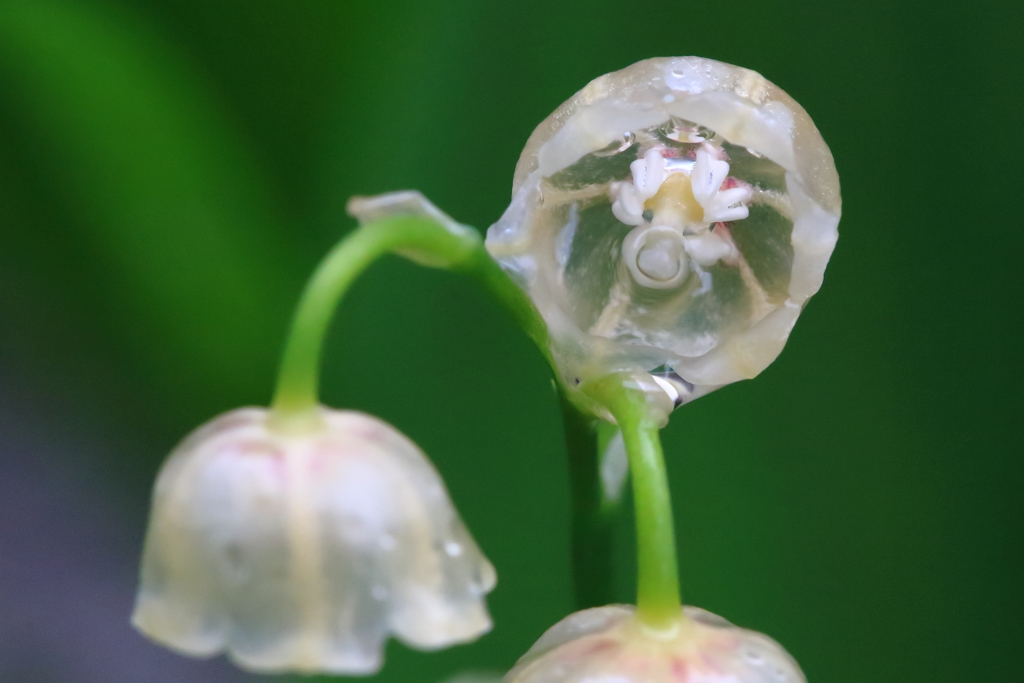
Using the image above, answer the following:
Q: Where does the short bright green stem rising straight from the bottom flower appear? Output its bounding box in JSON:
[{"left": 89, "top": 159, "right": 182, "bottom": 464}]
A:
[{"left": 584, "top": 376, "right": 681, "bottom": 629}]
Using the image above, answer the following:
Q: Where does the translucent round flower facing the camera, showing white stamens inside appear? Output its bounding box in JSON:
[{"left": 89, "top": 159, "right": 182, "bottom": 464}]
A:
[{"left": 486, "top": 57, "right": 840, "bottom": 403}]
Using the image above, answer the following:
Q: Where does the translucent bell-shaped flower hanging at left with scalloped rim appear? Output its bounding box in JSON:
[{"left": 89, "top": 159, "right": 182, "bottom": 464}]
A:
[{"left": 132, "top": 408, "right": 495, "bottom": 674}]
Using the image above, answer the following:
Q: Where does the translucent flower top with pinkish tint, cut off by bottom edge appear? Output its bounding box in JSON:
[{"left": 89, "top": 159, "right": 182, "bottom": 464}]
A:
[{"left": 505, "top": 605, "right": 806, "bottom": 683}]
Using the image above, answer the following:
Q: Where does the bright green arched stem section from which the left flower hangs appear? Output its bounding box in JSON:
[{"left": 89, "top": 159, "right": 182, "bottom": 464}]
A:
[{"left": 272, "top": 215, "right": 551, "bottom": 422}]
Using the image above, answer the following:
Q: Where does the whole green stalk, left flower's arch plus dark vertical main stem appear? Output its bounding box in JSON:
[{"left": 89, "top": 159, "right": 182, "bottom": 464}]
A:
[{"left": 264, "top": 210, "right": 633, "bottom": 609}]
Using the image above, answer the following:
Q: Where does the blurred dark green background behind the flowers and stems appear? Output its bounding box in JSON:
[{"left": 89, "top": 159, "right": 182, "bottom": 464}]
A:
[{"left": 0, "top": 0, "right": 1024, "bottom": 683}]
